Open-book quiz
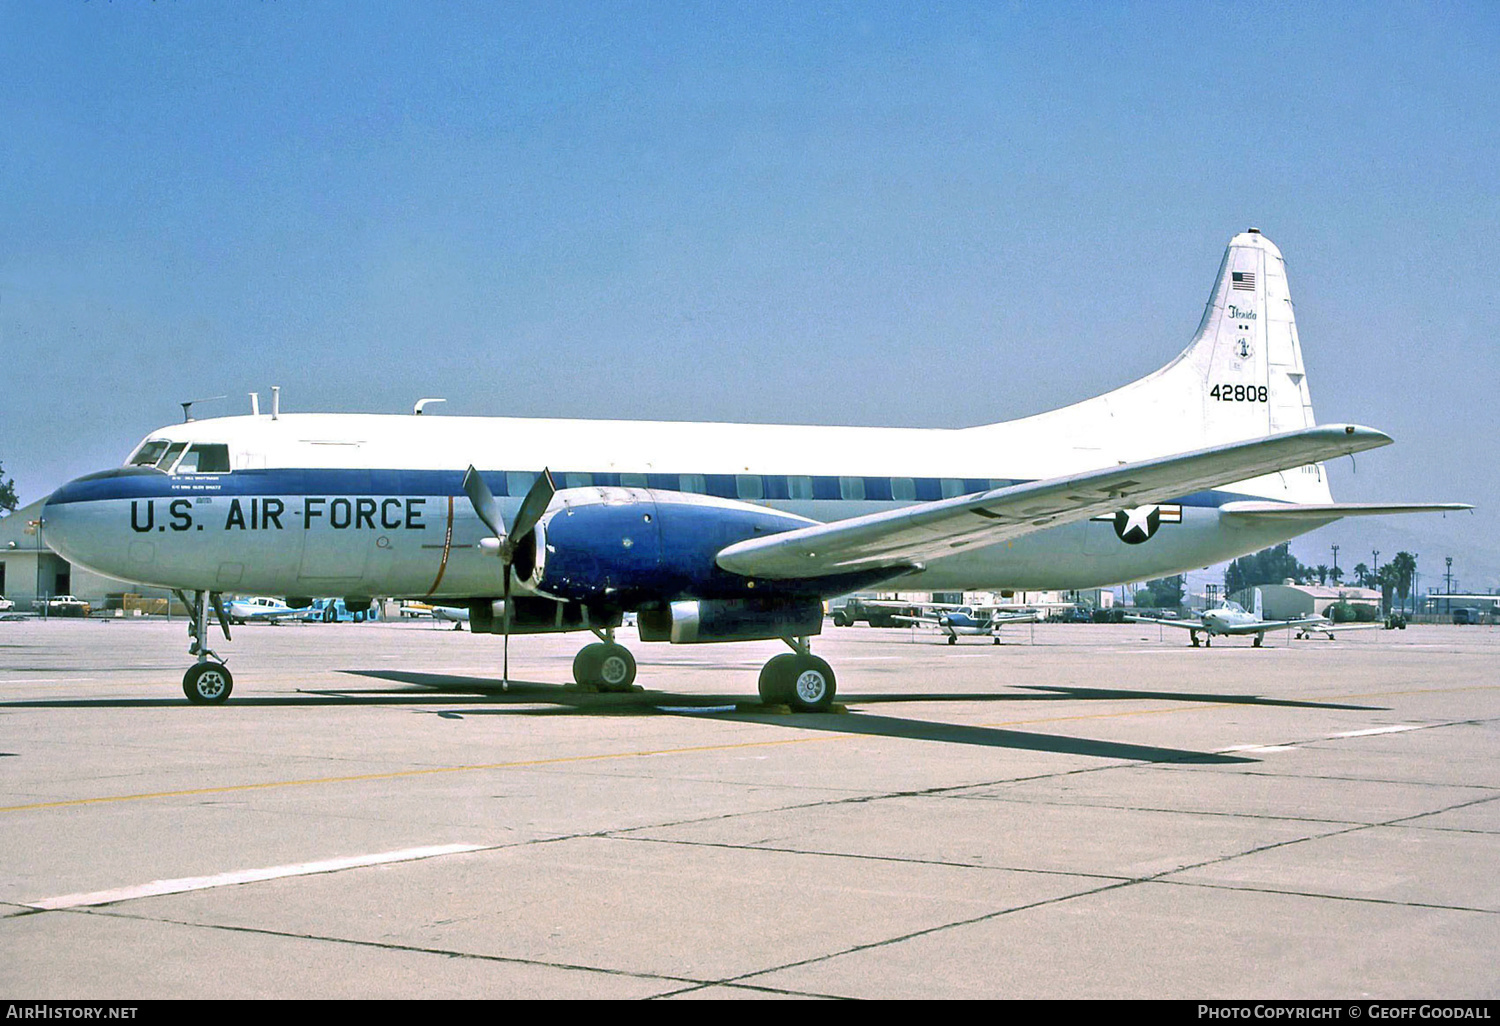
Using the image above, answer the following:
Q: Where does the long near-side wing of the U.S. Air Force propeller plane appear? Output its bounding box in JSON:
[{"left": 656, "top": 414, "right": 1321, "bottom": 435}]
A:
[{"left": 717, "top": 425, "right": 1391, "bottom": 581}]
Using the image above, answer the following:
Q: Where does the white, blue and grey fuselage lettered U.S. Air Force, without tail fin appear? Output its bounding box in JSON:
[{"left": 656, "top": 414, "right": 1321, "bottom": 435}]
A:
[{"left": 45, "top": 414, "right": 1326, "bottom": 600}]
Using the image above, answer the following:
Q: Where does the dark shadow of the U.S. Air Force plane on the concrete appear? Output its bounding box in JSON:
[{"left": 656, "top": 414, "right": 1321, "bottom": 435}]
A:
[{"left": 0, "top": 669, "right": 1380, "bottom": 765}]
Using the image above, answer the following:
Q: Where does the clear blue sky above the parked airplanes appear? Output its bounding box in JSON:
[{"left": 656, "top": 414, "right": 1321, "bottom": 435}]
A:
[{"left": 0, "top": 0, "right": 1500, "bottom": 588}]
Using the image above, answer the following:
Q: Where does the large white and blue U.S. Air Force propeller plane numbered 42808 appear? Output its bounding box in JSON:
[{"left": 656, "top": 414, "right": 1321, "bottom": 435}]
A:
[{"left": 44, "top": 228, "right": 1467, "bottom": 711}]
